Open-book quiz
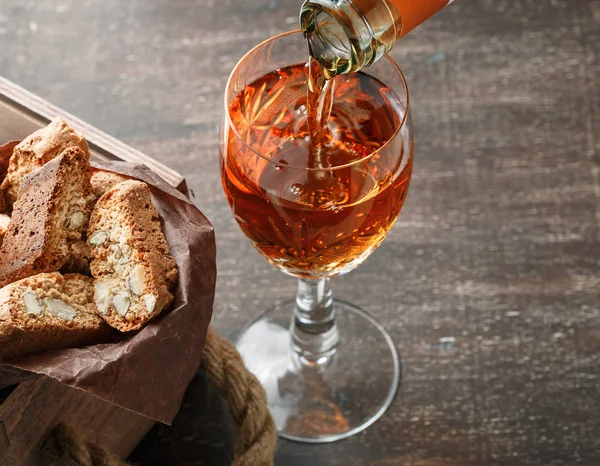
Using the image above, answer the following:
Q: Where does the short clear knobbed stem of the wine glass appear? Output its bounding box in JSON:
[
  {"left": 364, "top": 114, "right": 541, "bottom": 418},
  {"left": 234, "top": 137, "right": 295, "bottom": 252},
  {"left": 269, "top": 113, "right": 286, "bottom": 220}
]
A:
[{"left": 291, "top": 278, "right": 339, "bottom": 365}]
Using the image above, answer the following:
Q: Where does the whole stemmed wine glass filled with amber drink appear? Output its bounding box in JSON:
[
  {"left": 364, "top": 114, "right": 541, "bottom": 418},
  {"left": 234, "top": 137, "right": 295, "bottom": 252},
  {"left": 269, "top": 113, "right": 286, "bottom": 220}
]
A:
[{"left": 220, "top": 31, "right": 413, "bottom": 443}]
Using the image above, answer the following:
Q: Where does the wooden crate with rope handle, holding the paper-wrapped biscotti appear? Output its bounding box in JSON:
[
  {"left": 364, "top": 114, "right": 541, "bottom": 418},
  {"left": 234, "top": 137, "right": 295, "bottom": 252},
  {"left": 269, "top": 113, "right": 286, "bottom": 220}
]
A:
[{"left": 0, "top": 77, "right": 186, "bottom": 466}]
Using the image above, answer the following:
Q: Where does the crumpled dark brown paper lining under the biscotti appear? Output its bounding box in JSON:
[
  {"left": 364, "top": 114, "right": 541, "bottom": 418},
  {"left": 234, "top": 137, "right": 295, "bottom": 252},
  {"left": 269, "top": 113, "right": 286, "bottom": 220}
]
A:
[{"left": 0, "top": 145, "right": 216, "bottom": 424}]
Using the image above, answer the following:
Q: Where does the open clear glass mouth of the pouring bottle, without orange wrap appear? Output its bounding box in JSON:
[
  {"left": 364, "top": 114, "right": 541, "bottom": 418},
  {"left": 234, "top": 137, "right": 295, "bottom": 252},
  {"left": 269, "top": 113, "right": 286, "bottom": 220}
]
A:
[{"left": 300, "top": 0, "right": 371, "bottom": 79}]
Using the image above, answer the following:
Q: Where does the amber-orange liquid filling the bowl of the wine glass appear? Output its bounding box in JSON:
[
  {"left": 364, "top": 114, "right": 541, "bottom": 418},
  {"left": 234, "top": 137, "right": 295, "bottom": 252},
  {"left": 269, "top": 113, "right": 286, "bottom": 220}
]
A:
[{"left": 221, "top": 63, "right": 412, "bottom": 277}]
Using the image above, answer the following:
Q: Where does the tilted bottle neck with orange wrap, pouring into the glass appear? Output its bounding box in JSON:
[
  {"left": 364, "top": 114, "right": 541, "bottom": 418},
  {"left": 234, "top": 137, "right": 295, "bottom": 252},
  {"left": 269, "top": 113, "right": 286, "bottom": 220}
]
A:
[{"left": 300, "top": 0, "right": 453, "bottom": 78}]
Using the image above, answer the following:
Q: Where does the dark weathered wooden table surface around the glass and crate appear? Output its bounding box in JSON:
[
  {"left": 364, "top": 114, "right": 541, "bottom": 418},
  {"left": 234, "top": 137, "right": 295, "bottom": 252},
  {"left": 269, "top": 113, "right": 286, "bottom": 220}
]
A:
[{"left": 0, "top": 0, "right": 600, "bottom": 466}]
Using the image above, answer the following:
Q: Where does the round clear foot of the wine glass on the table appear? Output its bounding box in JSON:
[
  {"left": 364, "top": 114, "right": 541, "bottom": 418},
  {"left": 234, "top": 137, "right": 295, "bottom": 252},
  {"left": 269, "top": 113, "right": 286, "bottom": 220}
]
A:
[{"left": 237, "top": 300, "right": 401, "bottom": 443}]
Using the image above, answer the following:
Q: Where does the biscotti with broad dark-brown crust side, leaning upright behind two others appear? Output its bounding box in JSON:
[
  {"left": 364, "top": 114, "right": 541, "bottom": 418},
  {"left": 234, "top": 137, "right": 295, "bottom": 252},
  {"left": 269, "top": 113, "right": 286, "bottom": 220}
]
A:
[{"left": 0, "top": 147, "right": 91, "bottom": 287}]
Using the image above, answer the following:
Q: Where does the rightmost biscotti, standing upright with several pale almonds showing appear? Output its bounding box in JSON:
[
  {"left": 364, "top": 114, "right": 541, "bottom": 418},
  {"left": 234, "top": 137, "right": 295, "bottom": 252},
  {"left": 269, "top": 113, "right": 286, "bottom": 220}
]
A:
[{"left": 88, "top": 180, "right": 177, "bottom": 332}]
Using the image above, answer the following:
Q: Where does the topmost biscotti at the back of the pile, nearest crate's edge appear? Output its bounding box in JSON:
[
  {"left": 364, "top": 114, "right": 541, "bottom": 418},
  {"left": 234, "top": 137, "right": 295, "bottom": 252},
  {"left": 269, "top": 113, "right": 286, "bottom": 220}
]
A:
[{"left": 0, "top": 118, "right": 89, "bottom": 211}]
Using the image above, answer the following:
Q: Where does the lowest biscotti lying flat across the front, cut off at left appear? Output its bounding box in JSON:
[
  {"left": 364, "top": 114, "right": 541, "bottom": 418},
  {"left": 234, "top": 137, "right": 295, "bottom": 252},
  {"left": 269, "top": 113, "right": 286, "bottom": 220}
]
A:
[{"left": 0, "top": 272, "right": 114, "bottom": 361}]
